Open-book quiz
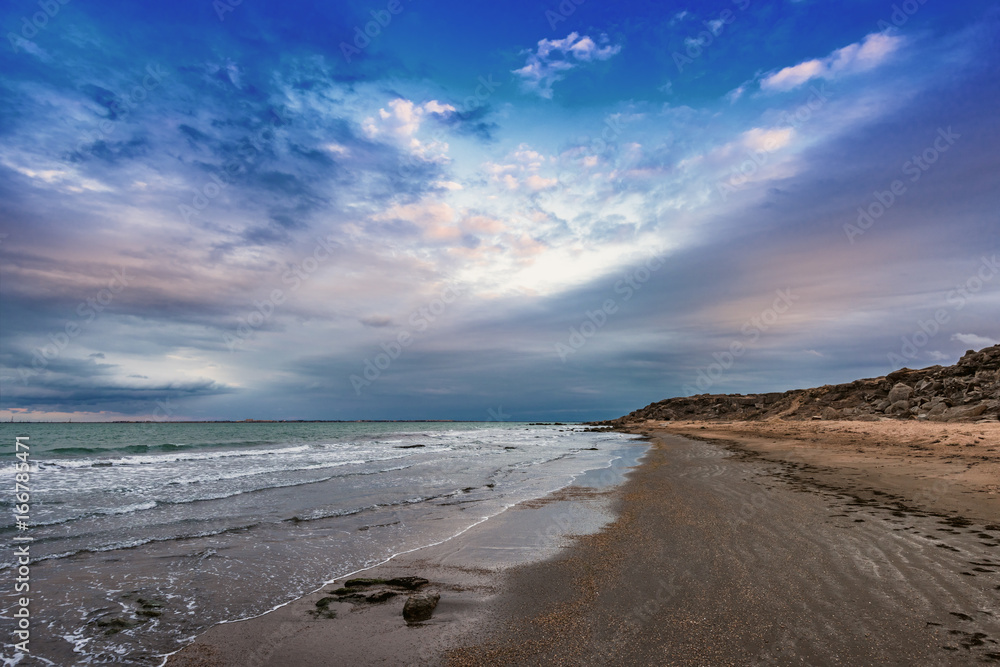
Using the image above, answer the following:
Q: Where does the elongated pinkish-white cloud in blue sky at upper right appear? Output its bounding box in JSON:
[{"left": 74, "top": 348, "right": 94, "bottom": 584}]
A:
[{"left": 760, "top": 33, "right": 904, "bottom": 92}]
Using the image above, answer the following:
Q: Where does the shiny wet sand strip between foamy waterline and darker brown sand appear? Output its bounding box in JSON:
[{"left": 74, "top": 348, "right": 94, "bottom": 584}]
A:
[{"left": 160, "top": 439, "right": 648, "bottom": 667}]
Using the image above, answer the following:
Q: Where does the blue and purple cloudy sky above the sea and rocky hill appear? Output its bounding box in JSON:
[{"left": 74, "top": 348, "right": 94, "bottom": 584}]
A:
[{"left": 0, "top": 0, "right": 1000, "bottom": 421}]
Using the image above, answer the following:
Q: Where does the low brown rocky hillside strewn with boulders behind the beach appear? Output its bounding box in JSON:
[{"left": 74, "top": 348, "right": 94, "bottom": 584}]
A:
[{"left": 595, "top": 345, "right": 1000, "bottom": 426}]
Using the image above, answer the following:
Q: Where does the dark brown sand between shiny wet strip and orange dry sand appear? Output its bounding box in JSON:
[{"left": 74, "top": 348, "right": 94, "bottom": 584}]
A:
[{"left": 447, "top": 422, "right": 1000, "bottom": 667}]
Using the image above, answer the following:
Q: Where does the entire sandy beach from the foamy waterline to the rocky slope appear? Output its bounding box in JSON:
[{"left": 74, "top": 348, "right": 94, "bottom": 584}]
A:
[{"left": 168, "top": 421, "right": 1000, "bottom": 665}]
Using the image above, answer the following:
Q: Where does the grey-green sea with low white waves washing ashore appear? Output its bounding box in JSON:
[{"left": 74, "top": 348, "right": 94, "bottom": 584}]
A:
[{"left": 0, "top": 422, "right": 639, "bottom": 665}]
